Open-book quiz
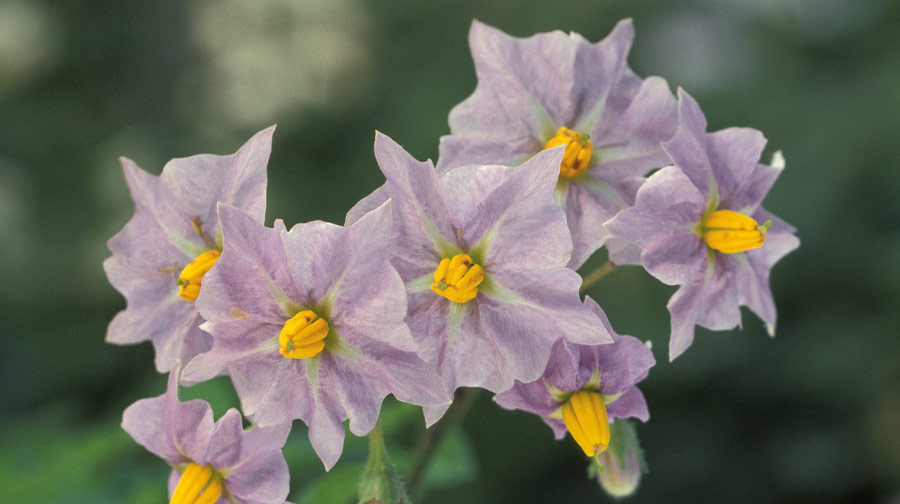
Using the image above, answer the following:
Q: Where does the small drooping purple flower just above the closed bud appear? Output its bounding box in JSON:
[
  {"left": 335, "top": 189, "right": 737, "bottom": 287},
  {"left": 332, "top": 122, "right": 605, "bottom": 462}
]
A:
[{"left": 494, "top": 297, "right": 656, "bottom": 456}]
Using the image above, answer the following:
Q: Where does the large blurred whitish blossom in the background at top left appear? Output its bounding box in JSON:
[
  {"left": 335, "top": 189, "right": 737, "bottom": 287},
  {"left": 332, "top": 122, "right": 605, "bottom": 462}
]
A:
[{"left": 185, "top": 0, "right": 372, "bottom": 128}]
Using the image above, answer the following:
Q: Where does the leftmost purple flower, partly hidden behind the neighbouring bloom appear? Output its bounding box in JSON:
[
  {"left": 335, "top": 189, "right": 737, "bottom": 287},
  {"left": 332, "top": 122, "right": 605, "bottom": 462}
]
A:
[{"left": 103, "top": 127, "right": 275, "bottom": 372}]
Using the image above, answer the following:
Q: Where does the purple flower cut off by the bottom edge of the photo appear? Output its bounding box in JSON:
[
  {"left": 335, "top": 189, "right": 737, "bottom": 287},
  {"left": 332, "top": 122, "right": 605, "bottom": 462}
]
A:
[{"left": 122, "top": 362, "right": 291, "bottom": 504}]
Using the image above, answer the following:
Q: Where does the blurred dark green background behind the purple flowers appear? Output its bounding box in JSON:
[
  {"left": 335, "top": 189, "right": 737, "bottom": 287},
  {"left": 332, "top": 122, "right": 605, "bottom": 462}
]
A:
[{"left": 0, "top": 0, "right": 900, "bottom": 504}]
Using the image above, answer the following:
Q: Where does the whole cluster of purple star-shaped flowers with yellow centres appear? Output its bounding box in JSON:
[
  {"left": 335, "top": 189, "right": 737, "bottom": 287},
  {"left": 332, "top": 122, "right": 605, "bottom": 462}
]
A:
[{"left": 104, "top": 20, "right": 799, "bottom": 504}]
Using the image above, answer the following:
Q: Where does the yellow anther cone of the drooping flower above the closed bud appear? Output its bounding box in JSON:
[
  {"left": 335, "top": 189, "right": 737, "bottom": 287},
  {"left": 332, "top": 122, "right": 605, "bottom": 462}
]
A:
[{"left": 562, "top": 390, "right": 609, "bottom": 457}]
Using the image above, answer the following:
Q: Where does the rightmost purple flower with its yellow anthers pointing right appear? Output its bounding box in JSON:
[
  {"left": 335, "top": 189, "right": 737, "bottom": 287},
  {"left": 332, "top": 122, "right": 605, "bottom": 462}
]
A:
[{"left": 606, "top": 90, "right": 800, "bottom": 360}]
